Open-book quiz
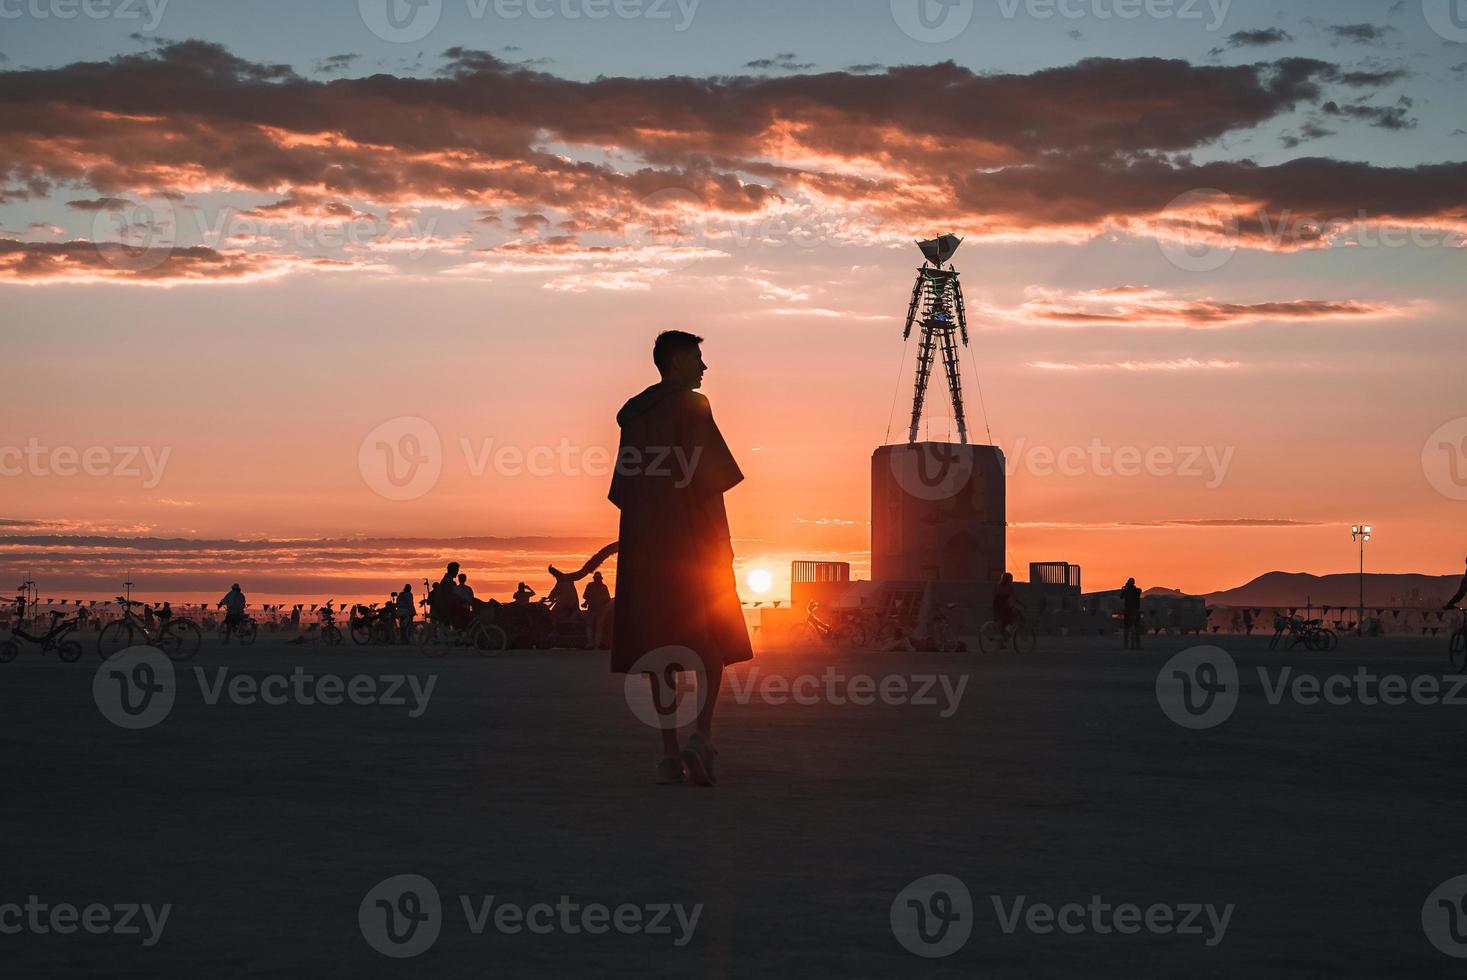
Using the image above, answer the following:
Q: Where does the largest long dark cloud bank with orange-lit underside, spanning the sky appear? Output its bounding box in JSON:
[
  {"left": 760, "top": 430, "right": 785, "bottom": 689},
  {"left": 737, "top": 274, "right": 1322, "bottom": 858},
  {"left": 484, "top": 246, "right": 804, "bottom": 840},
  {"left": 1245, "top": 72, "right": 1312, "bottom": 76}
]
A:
[{"left": 0, "top": 41, "right": 1467, "bottom": 264}]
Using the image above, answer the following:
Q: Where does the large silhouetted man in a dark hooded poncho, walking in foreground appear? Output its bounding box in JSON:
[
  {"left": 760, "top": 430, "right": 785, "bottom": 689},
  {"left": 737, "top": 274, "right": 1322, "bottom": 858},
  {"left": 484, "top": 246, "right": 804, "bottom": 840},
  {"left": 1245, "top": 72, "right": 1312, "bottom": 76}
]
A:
[{"left": 607, "top": 330, "right": 754, "bottom": 786}]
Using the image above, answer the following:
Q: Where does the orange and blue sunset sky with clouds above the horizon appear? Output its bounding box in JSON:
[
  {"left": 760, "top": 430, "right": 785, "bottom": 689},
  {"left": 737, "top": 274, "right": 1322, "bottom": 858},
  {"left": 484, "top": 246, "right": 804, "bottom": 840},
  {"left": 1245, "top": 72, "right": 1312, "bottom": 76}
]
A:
[{"left": 0, "top": 0, "right": 1467, "bottom": 596}]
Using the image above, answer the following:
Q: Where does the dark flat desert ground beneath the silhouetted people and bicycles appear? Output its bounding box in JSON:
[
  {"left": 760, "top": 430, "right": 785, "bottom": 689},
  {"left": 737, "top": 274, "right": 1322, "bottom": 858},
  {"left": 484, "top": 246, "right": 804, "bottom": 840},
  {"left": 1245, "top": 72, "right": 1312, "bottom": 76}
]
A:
[{"left": 0, "top": 638, "right": 1467, "bottom": 977}]
